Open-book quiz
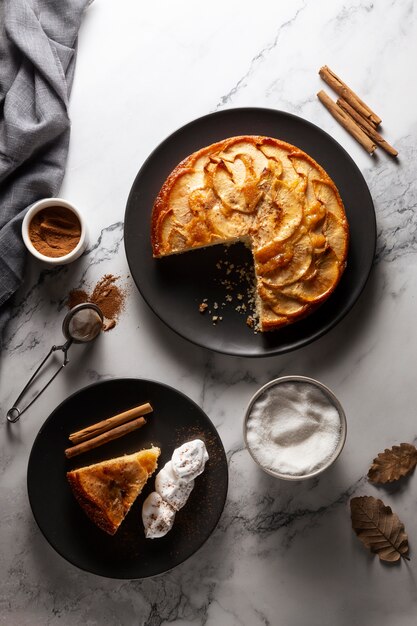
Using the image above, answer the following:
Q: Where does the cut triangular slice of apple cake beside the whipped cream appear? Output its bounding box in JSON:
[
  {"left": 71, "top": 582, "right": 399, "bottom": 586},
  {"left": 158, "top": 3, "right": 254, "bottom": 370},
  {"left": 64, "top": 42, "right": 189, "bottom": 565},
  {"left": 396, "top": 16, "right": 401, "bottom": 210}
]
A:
[{"left": 67, "top": 447, "right": 161, "bottom": 535}]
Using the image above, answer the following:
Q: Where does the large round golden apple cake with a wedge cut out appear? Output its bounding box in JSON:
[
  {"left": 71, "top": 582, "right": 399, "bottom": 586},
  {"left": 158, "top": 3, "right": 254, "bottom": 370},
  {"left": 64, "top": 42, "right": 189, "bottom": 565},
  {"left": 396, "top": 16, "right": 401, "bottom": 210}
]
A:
[{"left": 151, "top": 135, "right": 349, "bottom": 331}]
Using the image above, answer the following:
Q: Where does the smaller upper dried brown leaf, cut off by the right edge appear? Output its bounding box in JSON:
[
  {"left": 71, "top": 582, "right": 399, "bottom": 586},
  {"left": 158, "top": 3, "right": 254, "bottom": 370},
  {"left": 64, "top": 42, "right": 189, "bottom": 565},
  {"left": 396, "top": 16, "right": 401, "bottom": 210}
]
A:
[{"left": 368, "top": 443, "right": 417, "bottom": 484}]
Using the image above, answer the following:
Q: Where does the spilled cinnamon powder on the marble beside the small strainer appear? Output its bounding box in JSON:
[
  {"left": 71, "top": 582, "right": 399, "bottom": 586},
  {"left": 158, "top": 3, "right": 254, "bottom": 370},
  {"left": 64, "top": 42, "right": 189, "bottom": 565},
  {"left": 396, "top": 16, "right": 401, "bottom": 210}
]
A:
[{"left": 67, "top": 274, "right": 127, "bottom": 331}]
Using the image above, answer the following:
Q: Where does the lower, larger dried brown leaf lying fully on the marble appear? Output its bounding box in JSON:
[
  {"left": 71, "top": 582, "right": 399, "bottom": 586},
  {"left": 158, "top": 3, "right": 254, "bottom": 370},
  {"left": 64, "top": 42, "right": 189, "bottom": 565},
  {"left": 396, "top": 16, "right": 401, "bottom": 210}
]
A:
[{"left": 350, "top": 496, "right": 409, "bottom": 563}]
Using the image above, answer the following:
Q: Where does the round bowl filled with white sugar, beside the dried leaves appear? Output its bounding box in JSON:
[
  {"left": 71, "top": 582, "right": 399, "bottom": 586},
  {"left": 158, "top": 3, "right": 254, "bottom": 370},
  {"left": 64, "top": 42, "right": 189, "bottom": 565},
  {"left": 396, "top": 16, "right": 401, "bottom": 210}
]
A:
[{"left": 243, "top": 376, "right": 347, "bottom": 480}]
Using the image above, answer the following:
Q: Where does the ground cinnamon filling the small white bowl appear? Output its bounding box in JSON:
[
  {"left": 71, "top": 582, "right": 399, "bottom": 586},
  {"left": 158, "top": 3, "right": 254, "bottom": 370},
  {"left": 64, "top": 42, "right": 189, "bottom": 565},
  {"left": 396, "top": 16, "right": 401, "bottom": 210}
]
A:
[{"left": 29, "top": 206, "right": 81, "bottom": 258}]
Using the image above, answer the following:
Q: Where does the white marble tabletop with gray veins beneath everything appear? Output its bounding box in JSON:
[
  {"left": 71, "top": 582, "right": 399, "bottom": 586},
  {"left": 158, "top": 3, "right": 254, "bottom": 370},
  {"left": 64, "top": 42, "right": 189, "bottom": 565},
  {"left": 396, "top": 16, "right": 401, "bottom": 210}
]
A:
[{"left": 0, "top": 0, "right": 417, "bottom": 626}]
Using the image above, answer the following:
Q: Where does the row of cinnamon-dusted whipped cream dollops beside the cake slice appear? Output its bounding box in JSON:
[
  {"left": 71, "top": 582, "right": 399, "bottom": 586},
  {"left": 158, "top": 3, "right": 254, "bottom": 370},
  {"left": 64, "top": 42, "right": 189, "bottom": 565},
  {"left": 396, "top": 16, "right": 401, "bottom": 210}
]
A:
[{"left": 142, "top": 439, "right": 209, "bottom": 539}]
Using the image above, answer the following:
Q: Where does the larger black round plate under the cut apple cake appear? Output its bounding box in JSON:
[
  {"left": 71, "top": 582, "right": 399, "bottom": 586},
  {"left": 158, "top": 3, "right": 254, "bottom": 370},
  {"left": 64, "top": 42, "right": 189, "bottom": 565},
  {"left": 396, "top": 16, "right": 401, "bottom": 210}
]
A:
[{"left": 125, "top": 108, "right": 376, "bottom": 357}]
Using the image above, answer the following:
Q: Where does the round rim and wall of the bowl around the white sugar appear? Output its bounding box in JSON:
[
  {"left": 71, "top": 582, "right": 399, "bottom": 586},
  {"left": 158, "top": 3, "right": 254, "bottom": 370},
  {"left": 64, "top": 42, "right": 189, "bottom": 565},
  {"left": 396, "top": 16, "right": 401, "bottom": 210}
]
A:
[{"left": 243, "top": 376, "right": 347, "bottom": 480}]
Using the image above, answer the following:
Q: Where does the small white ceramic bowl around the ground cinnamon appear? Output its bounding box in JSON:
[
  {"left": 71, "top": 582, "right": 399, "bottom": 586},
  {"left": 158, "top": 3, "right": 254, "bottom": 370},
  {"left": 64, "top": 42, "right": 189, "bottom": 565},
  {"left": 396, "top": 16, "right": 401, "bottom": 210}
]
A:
[{"left": 22, "top": 198, "right": 88, "bottom": 265}]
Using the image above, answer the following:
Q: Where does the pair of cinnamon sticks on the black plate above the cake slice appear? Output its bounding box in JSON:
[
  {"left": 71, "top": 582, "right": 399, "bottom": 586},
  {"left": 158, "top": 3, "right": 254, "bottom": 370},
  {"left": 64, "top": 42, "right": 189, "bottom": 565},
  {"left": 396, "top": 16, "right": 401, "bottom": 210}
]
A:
[{"left": 65, "top": 402, "right": 153, "bottom": 459}]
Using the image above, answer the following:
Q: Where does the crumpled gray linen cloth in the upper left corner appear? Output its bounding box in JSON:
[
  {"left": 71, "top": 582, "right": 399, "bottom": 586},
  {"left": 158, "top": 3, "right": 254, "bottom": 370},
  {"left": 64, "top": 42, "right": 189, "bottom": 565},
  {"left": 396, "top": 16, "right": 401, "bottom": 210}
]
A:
[{"left": 0, "top": 0, "right": 91, "bottom": 345}]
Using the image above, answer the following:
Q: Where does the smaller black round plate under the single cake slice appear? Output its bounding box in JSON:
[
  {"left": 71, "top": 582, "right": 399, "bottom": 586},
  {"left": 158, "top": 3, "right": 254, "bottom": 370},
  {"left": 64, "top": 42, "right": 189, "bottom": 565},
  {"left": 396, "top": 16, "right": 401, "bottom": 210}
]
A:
[{"left": 27, "top": 378, "right": 228, "bottom": 578}]
